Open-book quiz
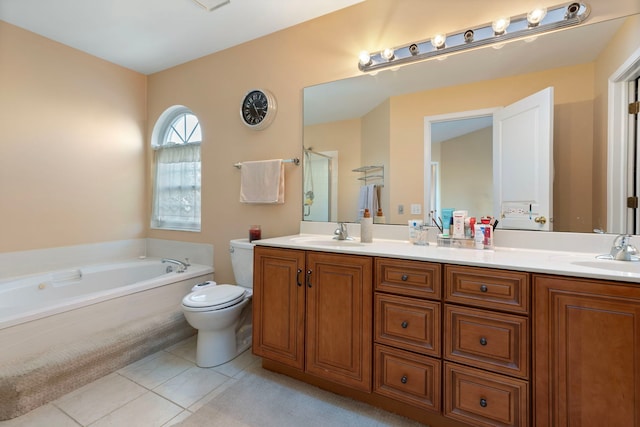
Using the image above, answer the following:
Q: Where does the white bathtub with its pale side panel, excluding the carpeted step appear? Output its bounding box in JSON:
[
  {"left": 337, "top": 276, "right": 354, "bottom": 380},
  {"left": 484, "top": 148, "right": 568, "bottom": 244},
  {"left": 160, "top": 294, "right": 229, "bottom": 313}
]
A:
[{"left": 0, "top": 258, "right": 213, "bottom": 363}]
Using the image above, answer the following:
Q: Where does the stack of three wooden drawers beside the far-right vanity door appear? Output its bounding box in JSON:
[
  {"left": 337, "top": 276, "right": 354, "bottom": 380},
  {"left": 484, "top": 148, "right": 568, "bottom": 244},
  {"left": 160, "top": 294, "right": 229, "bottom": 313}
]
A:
[{"left": 443, "top": 265, "right": 531, "bottom": 426}]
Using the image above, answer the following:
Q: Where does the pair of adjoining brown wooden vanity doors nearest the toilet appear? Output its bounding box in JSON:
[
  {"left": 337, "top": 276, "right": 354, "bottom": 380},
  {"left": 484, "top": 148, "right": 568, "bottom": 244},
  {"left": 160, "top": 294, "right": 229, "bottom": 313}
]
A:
[{"left": 253, "top": 246, "right": 373, "bottom": 392}]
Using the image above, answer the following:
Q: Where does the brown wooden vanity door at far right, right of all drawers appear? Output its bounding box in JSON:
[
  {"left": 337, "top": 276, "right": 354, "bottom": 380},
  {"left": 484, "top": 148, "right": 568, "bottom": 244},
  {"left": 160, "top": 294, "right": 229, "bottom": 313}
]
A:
[{"left": 533, "top": 276, "right": 640, "bottom": 427}]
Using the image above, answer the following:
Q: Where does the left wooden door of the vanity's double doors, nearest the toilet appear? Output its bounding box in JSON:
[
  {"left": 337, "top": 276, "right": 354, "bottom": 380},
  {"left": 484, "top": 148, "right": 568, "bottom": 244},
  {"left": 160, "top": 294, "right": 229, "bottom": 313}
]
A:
[{"left": 253, "top": 246, "right": 305, "bottom": 370}]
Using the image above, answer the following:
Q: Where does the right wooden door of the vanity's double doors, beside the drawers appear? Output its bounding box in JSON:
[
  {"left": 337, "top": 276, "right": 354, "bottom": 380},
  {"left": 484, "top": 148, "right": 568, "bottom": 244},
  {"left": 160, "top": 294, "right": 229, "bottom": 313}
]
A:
[{"left": 305, "top": 252, "right": 373, "bottom": 391}]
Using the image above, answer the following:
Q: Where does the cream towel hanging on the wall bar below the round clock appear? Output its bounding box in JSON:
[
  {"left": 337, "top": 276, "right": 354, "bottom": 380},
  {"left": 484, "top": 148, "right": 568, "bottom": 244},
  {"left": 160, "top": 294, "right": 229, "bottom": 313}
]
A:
[{"left": 240, "top": 159, "right": 284, "bottom": 203}]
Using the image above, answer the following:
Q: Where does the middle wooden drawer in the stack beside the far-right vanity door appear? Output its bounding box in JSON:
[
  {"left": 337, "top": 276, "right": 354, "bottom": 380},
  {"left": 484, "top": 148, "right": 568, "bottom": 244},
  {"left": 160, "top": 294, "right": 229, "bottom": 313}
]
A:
[{"left": 444, "top": 304, "right": 529, "bottom": 379}]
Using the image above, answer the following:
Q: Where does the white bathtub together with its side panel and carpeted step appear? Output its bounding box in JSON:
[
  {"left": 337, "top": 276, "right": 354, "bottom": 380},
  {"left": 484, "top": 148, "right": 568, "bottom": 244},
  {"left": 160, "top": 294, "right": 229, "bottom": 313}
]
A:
[{"left": 0, "top": 258, "right": 213, "bottom": 420}]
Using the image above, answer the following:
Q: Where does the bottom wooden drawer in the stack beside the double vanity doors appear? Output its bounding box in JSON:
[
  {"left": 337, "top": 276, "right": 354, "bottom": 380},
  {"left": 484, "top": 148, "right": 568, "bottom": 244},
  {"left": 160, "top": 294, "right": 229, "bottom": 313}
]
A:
[{"left": 374, "top": 344, "right": 441, "bottom": 412}]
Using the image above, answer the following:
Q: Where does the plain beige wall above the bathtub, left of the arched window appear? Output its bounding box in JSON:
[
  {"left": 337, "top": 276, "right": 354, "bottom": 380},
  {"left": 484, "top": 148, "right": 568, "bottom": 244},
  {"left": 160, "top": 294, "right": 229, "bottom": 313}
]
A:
[{"left": 0, "top": 21, "right": 147, "bottom": 252}]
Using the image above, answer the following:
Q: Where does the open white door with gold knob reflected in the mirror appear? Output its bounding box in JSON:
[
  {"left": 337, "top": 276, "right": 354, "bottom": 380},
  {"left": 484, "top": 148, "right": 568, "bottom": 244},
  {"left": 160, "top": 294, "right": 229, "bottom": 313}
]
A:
[{"left": 493, "top": 87, "right": 553, "bottom": 231}]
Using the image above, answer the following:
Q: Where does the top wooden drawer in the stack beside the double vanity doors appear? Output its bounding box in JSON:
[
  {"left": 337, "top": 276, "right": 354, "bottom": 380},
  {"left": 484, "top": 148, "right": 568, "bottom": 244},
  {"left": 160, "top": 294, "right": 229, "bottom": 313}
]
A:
[{"left": 375, "top": 258, "right": 442, "bottom": 299}]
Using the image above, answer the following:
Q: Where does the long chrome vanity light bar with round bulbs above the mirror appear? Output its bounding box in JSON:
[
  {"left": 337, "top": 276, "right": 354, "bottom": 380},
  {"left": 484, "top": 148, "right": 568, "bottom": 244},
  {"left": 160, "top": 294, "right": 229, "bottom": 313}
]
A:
[{"left": 358, "top": 2, "right": 591, "bottom": 72}]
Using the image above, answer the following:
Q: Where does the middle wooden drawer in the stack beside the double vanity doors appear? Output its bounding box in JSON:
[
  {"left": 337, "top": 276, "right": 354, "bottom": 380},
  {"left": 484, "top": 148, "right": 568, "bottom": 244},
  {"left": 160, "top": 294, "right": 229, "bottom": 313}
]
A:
[{"left": 374, "top": 293, "right": 441, "bottom": 356}]
